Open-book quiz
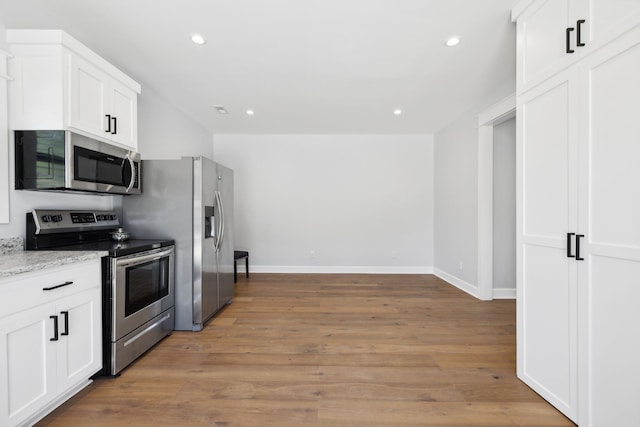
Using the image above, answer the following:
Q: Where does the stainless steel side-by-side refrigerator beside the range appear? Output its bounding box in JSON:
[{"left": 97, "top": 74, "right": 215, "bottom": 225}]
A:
[{"left": 122, "top": 157, "right": 234, "bottom": 331}]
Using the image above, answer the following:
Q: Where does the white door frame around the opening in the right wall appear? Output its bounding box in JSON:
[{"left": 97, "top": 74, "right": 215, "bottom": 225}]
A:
[{"left": 477, "top": 94, "right": 516, "bottom": 300}]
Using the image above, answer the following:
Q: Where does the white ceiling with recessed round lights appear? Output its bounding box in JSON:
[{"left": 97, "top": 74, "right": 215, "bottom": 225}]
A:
[{"left": 0, "top": 0, "right": 517, "bottom": 134}]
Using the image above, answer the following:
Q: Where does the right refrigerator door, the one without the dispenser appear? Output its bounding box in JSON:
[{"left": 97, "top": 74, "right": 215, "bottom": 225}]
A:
[{"left": 216, "top": 164, "right": 234, "bottom": 306}]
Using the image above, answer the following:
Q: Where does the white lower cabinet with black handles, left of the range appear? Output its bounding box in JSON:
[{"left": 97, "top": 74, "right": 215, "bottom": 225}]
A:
[{"left": 0, "top": 259, "right": 102, "bottom": 426}]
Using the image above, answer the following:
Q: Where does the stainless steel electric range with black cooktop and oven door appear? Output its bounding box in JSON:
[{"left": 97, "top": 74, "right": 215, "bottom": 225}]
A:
[{"left": 26, "top": 209, "right": 175, "bottom": 375}]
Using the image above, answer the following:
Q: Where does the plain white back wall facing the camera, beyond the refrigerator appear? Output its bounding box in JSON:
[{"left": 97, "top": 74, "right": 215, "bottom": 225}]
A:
[{"left": 214, "top": 135, "right": 433, "bottom": 273}]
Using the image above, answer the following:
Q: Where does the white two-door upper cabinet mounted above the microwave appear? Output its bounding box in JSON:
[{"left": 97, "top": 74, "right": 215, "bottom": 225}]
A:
[{"left": 7, "top": 30, "right": 140, "bottom": 151}]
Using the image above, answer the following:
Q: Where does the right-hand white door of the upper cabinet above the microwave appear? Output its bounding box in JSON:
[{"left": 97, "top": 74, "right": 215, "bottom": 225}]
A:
[{"left": 110, "top": 80, "right": 138, "bottom": 151}]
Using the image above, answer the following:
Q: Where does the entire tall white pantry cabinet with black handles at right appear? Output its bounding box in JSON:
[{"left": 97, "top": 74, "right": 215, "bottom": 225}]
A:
[{"left": 514, "top": 0, "right": 640, "bottom": 426}]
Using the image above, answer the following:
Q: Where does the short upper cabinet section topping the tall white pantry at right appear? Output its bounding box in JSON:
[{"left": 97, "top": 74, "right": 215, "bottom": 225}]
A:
[{"left": 512, "top": 0, "right": 640, "bottom": 93}]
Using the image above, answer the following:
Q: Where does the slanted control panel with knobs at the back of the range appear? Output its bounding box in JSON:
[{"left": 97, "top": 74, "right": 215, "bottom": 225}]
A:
[{"left": 27, "top": 209, "right": 120, "bottom": 234}]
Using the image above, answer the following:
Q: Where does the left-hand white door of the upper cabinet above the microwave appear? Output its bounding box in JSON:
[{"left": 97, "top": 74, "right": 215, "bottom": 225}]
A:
[{"left": 67, "top": 54, "right": 110, "bottom": 138}]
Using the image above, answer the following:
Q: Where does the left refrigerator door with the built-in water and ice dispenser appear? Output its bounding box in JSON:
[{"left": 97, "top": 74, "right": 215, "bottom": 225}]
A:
[{"left": 193, "top": 157, "right": 221, "bottom": 331}]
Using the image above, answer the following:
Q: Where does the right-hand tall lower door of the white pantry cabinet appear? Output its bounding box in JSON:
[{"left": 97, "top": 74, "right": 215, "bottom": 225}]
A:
[{"left": 579, "top": 29, "right": 640, "bottom": 426}]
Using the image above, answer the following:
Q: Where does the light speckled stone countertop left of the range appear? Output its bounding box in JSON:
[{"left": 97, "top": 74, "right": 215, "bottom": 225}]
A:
[{"left": 0, "top": 251, "right": 109, "bottom": 279}]
